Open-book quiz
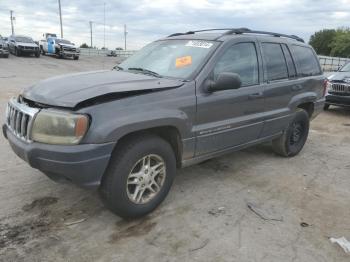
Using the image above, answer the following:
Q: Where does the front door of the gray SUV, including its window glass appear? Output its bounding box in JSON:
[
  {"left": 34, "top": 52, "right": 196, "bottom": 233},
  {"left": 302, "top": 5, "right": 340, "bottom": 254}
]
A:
[{"left": 195, "top": 42, "right": 264, "bottom": 156}]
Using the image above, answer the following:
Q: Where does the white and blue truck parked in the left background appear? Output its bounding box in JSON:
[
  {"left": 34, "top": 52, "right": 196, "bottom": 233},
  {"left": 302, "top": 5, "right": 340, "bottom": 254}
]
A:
[{"left": 40, "top": 36, "right": 80, "bottom": 60}]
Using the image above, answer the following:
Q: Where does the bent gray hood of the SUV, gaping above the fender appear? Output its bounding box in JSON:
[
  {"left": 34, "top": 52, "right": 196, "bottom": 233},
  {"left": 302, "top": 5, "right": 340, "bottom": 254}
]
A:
[{"left": 22, "top": 70, "right": 183, "bottom": 108}]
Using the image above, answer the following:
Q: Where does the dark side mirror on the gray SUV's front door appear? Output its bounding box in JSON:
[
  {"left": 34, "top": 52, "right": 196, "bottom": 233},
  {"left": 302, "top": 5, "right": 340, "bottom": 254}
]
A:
[{"left": 206, "top": 72, "right": 242, "bottom": 92}]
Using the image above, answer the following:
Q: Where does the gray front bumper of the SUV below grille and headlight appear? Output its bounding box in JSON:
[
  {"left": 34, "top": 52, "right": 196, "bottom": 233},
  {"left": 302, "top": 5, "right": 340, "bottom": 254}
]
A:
[{"left": 3, "top": 125, "right": 115, "bottom": 188}]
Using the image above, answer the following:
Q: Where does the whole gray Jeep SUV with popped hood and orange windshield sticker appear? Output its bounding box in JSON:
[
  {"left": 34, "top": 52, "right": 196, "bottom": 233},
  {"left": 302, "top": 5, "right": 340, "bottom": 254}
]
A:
[{"left": 3, "top": 28, "right": 325, "bottom": 217}]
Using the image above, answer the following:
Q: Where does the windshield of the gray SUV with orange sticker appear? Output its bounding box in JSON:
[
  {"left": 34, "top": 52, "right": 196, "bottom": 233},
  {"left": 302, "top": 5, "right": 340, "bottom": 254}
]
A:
[{"left": 117, "top": 40, "right": 218, "bottom": 78}]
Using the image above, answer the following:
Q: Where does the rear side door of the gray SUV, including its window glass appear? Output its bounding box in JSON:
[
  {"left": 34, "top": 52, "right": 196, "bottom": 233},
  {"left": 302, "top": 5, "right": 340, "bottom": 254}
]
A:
[{"left": 261, "top": 42, "right": 296, "bottom": 137}]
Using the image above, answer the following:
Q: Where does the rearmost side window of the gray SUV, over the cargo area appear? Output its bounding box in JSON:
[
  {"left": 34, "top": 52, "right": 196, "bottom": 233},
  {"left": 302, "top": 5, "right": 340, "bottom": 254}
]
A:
[{"left": 291, "top": 45, "right": 321, "bottom": 76}]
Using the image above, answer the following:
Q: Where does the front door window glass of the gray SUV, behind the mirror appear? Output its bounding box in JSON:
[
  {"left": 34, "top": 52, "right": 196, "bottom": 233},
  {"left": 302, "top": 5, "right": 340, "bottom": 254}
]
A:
[{"left": 213, "top": 43, "right": 259, "bottom": 86}]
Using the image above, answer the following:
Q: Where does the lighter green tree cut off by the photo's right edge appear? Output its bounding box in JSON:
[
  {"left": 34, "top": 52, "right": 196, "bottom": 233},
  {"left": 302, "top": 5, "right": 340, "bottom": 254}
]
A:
[{"left": 331, "top": 28, "right": 350, "bottom": 57}]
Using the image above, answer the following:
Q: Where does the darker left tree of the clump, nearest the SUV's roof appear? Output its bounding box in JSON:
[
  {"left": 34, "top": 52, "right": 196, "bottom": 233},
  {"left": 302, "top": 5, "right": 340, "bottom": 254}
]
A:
[{"left": 309, "top": 29, "right": 336, "bottom": 56}]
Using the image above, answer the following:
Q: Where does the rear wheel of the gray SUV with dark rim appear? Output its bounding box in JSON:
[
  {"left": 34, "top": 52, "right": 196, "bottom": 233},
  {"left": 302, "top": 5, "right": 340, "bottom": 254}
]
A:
[{"left": 272, "top": 109, "right": 310, "bottom": 157}]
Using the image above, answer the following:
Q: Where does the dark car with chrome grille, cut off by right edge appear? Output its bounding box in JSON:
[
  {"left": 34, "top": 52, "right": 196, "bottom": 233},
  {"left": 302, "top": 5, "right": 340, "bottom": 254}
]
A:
[{"left": 324, "top": 63, "right": 350, "bottom": 110}]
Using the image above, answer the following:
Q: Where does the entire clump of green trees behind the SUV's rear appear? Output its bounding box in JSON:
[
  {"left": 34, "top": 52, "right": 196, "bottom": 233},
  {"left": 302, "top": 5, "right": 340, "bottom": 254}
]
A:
[{"left": 309, "top": 28, "right": 350, "bottom": 57}]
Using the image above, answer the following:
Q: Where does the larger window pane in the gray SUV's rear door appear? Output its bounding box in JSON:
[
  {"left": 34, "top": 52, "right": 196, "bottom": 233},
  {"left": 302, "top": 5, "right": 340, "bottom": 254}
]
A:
[{"left": 262, "top": 43, "right": 288, "bottom": 81}]
